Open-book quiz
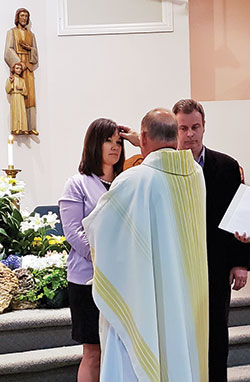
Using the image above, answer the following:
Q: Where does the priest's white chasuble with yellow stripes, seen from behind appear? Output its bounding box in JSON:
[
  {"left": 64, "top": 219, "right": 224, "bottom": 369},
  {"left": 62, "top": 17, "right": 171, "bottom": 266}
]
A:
[{"left": 83, "top": 149, "right": 208, "bottom": 382}]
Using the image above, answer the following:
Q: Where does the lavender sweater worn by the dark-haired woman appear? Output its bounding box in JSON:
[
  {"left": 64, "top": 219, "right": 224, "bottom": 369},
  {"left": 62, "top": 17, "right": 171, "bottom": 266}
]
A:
[{"left": 59, "top": 174, "right": 107, "bottom": 284}]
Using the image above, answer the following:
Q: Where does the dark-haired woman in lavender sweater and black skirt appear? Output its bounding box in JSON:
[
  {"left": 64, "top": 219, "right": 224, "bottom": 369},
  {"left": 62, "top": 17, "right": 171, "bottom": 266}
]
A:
[{"left": 59, "top": 118, "right": 124, "bottom": 382}]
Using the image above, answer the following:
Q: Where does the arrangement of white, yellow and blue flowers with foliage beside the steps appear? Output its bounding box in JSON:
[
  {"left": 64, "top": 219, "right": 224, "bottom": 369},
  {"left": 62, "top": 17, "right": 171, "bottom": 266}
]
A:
[{"left": 0, "top": 177, "right": 70, "bottom": 309}]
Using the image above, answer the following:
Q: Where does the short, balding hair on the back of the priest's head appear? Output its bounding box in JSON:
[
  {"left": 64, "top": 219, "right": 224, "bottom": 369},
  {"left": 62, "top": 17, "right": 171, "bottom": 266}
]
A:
[{"left": 141, "top": 108, "right": 178, "bottom": 142}]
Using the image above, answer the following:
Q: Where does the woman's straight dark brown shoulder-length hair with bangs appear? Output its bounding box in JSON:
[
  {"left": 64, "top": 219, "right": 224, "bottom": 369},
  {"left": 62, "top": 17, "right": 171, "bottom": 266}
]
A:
[{"left": 78, "top": 118, "right": 125, "bottom": 176}]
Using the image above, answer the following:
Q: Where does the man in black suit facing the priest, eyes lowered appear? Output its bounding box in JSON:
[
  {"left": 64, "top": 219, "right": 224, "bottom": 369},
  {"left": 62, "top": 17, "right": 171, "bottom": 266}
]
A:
[{"left": 173, "top": 99, "right": 248, "bottom": 382}]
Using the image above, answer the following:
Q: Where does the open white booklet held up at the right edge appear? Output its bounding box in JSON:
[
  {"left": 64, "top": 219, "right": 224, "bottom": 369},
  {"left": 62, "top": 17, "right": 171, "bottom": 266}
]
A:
[{"left": 219, "top": 184, "right": 250, "bottom": 236}]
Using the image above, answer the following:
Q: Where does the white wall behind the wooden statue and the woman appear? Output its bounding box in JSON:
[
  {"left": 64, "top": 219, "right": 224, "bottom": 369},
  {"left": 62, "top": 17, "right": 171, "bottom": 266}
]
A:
[{"left": 0, "top": 0, "right": 190, "bottom": 209}]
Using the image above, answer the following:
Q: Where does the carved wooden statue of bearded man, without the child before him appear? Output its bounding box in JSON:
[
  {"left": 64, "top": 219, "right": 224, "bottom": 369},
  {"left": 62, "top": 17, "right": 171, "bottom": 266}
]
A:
[{"left": 4, "top": 8, "right": 39, "bottom": 135}]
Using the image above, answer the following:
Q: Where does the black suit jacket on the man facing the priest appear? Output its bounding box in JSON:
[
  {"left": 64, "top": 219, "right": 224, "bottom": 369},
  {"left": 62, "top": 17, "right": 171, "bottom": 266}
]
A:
[{"left": 203, "top": 148, "right": 249, "bottom": 280}]
